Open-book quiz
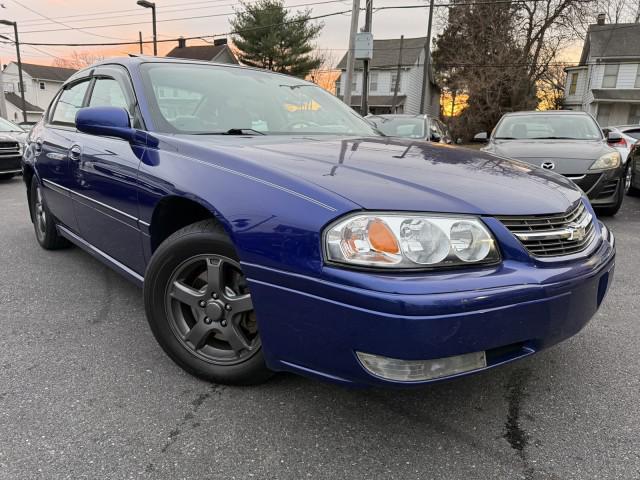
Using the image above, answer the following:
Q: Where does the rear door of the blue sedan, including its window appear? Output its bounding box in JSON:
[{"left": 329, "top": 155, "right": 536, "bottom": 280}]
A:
[{"left": 33, "top": 77, "right": 90, "bottom": 232}]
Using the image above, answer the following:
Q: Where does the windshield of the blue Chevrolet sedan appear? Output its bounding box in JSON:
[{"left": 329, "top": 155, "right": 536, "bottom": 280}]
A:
[{"left": 141, "top": 63, "right": 379, "bottom": 136}]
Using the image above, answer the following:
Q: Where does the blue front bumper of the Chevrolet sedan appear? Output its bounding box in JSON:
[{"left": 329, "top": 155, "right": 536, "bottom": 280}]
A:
[{"left": 243, "top": 224, "right": 615, "bottom": 386}]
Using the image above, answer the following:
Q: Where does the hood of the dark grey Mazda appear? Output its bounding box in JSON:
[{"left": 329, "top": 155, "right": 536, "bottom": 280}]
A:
[{"left": 485, "top": 140, "right": 614, "bottom": 175}]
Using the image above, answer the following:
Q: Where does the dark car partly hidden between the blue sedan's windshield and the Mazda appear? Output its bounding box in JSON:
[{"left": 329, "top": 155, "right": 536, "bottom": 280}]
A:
[{"left": 365, "top": 114, "right": 451, "bottom": 143}]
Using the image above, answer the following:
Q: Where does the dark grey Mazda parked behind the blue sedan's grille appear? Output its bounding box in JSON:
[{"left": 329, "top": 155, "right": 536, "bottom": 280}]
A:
[{"left": 474, "top": 110, "right": 629, "bottom": 215}]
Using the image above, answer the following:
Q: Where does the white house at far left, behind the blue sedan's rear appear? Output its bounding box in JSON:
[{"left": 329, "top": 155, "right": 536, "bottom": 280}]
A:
[{"left": 2, "top": 62, "right": 76, "bottom": 122}]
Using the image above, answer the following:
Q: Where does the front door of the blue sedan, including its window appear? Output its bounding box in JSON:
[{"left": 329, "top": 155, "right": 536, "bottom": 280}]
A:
[{"left": 71, "top": 65, "right": 145, "bottom": 274}]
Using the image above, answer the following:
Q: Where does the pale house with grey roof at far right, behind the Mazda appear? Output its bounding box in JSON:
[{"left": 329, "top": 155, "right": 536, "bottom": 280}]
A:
[{"left": 565, "top": 16, "right": 640, "bottom": 127}]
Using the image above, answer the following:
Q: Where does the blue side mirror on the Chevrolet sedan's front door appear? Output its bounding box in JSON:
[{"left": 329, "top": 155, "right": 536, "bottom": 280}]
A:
[{"left": 76, "top": 107, "right": 136, "bottom": 142}]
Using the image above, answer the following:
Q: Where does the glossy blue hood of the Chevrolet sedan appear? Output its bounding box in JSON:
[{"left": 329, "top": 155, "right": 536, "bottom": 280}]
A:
[{"left": 172, "top": 136, "right": 581, "bottom": 215}]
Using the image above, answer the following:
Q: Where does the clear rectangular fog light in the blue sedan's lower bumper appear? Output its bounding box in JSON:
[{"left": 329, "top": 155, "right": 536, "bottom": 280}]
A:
[{"left": 356, "top": 352, "right": 487, "bottom": 382}]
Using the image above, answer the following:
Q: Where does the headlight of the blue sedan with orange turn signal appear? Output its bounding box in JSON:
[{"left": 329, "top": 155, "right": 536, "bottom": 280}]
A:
[{"left": 323, "top": 213, "right": 500, "bottom": 269}]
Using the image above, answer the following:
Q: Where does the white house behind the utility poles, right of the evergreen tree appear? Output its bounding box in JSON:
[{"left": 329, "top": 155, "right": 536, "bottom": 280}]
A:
[{"left": 336, "top": 37, "right": 440, "bottom": 117}]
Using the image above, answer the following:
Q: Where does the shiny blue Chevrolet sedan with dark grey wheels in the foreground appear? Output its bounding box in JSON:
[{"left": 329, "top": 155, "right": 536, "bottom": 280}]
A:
[{"left": 24, "top": 57, "right": 615, "bottom": 386}]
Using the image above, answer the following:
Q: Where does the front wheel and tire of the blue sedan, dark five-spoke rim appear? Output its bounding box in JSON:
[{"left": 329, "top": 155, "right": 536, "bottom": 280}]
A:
[{"left": 144, "top": 220, "right": 273, "bottom": 385}]
